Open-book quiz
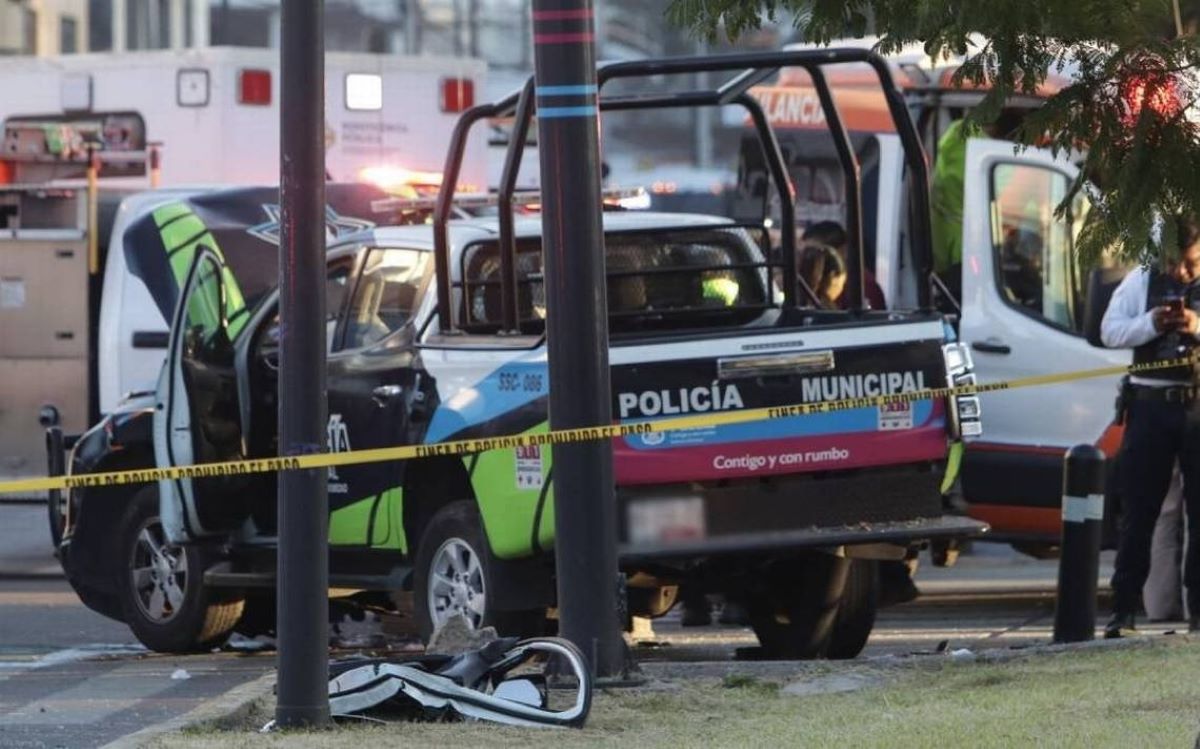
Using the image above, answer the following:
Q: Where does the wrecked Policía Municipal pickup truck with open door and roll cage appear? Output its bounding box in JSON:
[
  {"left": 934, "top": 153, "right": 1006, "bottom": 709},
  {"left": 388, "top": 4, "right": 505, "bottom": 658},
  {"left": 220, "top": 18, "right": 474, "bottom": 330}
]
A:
[{"left": 49, "top": 50, "right": 984, "bottom": 658}]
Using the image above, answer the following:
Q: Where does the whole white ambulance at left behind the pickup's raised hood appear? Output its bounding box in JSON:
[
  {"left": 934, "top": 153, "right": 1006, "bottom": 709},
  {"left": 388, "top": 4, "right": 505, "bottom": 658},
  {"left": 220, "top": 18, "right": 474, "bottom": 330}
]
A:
[{"left": 0, "top": 48, "right": 487, "bottom": 492}]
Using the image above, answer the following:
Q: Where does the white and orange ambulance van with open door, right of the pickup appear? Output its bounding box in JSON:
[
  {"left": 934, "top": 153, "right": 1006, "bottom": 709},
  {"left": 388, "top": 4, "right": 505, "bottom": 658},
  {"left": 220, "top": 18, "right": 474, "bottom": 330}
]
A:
[{"left": 738, "top": 42, "right": 1129, "bottom": 552}]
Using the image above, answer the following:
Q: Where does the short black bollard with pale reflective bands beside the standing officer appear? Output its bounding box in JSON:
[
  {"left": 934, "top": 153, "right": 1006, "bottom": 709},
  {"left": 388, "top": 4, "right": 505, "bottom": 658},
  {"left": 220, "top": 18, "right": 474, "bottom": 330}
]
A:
[{"left": 1054, "top": 444, "right": 1105, "bottom": 642}]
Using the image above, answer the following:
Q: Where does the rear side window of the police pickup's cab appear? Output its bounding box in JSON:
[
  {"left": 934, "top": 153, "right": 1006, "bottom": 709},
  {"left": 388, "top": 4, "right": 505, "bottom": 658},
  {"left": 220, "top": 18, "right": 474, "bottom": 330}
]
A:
[{"left": 344, "top": 248, "right": 432, "bottom": 348}]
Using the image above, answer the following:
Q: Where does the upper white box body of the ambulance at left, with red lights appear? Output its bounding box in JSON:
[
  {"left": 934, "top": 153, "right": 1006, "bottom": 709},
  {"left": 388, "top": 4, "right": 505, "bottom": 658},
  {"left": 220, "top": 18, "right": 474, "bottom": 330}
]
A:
[{"left": 0, "top": 47, "right": 487, "bottom": 188}]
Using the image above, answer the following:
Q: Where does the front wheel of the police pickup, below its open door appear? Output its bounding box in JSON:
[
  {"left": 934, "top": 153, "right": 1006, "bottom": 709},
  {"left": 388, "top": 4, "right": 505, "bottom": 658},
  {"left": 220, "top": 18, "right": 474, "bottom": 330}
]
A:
[{"left": 116, "top": 486, "right": 242, "bottom": 653}]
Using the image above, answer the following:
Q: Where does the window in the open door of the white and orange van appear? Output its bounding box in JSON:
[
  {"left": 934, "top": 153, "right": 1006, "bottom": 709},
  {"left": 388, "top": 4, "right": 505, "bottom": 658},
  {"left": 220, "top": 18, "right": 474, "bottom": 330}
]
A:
[{"left": 991, "top": 163, "right": 1080, "bottom": 331}]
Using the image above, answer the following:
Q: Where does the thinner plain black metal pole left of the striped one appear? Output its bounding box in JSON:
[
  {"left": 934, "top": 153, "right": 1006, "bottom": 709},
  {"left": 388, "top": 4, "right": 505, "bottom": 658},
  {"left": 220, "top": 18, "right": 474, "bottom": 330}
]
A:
[{"left": 275, "top": 0, "right": 329, "bottom": 727}]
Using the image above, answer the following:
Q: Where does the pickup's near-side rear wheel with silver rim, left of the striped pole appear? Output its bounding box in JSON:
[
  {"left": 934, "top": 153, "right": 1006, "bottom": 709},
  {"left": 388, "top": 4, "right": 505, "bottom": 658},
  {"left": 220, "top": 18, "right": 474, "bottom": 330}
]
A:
[{"left": 413, "top": 499, "right": 546, "bottom": 642}]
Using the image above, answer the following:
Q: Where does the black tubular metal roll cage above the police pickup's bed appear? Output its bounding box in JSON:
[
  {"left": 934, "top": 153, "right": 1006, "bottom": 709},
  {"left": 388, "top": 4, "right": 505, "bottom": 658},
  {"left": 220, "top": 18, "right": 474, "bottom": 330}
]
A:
[{"left": 433, "top": 49, "right": 944, "bottom": 332}]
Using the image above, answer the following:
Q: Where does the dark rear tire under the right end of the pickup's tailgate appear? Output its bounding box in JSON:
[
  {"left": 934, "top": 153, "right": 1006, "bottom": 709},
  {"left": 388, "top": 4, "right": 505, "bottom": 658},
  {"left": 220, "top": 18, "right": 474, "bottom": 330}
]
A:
[{"left": 746, "top": 553, "right": 850, "bottom": 659}]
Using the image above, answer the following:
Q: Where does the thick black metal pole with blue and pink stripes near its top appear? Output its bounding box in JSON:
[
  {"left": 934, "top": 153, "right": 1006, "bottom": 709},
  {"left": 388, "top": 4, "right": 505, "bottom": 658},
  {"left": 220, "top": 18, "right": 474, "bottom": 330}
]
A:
[{"left": 533, "top": 0, "right": 625, "bottom": 677}]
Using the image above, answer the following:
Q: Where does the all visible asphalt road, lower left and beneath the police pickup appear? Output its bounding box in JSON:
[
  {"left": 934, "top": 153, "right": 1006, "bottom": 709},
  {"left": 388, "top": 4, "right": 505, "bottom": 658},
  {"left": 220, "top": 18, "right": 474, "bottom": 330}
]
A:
[{"left": 0, "top": 507, "right": 1175, "bottom": 749}]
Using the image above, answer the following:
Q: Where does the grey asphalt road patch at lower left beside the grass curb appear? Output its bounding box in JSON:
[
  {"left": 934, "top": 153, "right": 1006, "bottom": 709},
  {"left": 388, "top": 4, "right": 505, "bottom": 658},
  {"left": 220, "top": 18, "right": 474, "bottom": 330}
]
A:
[{"left": 0, "top": 505, "right": 274, "bottom": 749}]
